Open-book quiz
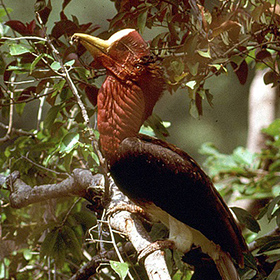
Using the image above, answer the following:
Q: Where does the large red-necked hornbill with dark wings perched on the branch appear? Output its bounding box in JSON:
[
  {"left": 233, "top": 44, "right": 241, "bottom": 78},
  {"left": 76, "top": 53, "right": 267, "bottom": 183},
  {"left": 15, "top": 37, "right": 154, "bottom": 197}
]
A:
[{"left": 72, "top": 28, "right": 247, "bottom": 280}]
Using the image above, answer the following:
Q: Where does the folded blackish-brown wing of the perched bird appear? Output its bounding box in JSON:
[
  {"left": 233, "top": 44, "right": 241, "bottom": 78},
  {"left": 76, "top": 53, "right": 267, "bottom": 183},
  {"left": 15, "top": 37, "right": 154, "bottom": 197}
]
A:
[{"left": 110, "top": 136, "right": 246, "bottom": 264}]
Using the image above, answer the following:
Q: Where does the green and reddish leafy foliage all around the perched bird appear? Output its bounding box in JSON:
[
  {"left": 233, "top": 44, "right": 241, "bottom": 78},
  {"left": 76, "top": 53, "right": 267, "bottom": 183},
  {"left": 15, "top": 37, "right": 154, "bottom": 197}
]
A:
[{"left": 0, "top": 0, "right": 280, "bottom": 279}]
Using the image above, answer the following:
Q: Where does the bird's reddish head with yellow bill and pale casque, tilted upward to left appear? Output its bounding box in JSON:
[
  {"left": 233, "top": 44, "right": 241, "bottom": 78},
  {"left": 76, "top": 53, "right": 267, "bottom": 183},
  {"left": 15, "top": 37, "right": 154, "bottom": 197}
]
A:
[{"left": 72, "top": 29, "right": 164, "bottom": 99}]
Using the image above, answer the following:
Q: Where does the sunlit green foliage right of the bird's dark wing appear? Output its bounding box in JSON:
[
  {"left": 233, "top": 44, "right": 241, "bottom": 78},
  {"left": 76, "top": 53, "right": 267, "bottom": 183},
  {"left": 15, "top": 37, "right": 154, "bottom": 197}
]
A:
[{"left": 201, "top": 119, "right": 280, "bottom": 279}]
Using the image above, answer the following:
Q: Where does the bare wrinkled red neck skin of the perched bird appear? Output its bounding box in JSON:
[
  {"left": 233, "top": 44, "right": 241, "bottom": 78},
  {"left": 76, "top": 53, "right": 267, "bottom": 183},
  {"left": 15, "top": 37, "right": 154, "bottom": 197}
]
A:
[{"left": 97, "top": 75, "right": 145, "bottom": 160}]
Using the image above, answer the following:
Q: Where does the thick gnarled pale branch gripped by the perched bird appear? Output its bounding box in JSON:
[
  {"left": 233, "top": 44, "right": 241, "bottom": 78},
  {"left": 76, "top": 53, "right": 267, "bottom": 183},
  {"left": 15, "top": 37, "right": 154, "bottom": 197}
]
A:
[{"left": 6, "top": 169, "right": 171, "bottom": 280}]
